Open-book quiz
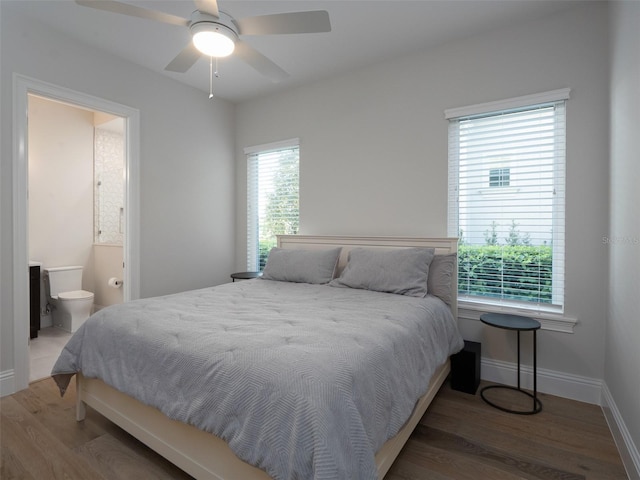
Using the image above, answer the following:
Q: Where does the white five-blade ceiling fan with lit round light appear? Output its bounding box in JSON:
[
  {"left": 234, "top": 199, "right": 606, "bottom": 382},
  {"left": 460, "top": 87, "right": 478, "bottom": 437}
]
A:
[{"left": 76, "top": 0, "right": 331, "bottom": 82}]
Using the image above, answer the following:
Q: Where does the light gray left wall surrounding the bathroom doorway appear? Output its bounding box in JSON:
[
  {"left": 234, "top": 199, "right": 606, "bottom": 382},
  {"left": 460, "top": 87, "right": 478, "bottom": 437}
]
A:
[{"left": 0, "top": 2, "right": 235, "bottom": 390}]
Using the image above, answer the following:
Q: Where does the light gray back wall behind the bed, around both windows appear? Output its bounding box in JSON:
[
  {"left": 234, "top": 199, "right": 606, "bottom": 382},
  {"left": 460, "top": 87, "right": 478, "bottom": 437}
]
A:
[{"left": 236, "top": 2, "right": 609, "bottom": 381}]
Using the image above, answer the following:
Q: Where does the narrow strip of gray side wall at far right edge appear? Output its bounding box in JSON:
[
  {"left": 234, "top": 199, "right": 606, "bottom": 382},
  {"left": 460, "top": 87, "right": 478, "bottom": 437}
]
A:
[{"left": 602, "top": 1, "right": 640, "bottom": 472}]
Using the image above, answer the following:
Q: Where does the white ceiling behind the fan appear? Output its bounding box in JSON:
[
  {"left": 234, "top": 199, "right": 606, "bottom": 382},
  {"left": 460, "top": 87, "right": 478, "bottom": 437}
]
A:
[{"left": 7, "top": 0, "right": 579, "bottom": 102}]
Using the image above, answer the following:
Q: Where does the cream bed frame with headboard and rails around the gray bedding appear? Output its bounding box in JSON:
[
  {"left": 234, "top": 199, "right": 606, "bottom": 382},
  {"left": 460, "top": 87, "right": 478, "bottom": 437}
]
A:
[{"left": 76, "top": 235, "right": 458, "bottom": 480}]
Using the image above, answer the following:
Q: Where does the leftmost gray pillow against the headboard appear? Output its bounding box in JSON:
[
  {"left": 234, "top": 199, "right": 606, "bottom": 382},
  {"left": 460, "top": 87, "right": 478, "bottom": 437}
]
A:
[{"left": 261, "top": 247, "right": 342, "bottom": 283}]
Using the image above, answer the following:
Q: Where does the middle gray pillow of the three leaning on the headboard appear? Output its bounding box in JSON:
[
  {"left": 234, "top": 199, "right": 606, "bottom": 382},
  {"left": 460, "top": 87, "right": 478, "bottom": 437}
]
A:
[{"left": 329, "top": 248, "right": 434, "bottom": 297}]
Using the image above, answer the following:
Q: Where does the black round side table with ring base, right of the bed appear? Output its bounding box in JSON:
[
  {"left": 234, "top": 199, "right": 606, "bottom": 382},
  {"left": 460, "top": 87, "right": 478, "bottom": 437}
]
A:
[{"left": 480, "top": 313, "right": 542, "bottom": 415}]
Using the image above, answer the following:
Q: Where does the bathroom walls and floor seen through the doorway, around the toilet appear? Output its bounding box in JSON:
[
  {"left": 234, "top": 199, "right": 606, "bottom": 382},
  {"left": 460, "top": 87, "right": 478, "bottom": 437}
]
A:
[{"left": 28, "top": 95, "right": 124, "bottom": 381}]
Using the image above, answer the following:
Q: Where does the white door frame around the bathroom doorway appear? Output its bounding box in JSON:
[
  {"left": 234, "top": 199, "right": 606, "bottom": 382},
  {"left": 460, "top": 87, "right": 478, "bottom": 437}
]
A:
[{"left": 13, "top": 73, "right": 140, "bottom": 392}]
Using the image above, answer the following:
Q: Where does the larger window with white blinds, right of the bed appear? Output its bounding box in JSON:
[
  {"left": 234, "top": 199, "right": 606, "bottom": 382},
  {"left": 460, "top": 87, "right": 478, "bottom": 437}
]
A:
[{"left": 445, "top": 89, "right": 569, "bottom": 311}]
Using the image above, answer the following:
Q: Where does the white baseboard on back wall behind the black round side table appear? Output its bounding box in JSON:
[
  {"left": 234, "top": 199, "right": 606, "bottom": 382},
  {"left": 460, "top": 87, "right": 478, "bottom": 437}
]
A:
[{"left": 481, "top": 358, "right": 602, "bottom": 405}]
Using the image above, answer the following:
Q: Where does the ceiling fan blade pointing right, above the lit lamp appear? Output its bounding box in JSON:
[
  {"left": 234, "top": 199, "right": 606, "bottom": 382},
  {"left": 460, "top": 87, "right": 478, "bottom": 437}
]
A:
[{"left": 236, "top": 10, "right": 331, "bottom": 35}]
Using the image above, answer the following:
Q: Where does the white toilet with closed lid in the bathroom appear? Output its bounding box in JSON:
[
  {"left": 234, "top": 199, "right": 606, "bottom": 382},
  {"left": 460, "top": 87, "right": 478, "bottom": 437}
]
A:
[{"left": 44, "top": 266, "right": 93, "bottom": 332}]
